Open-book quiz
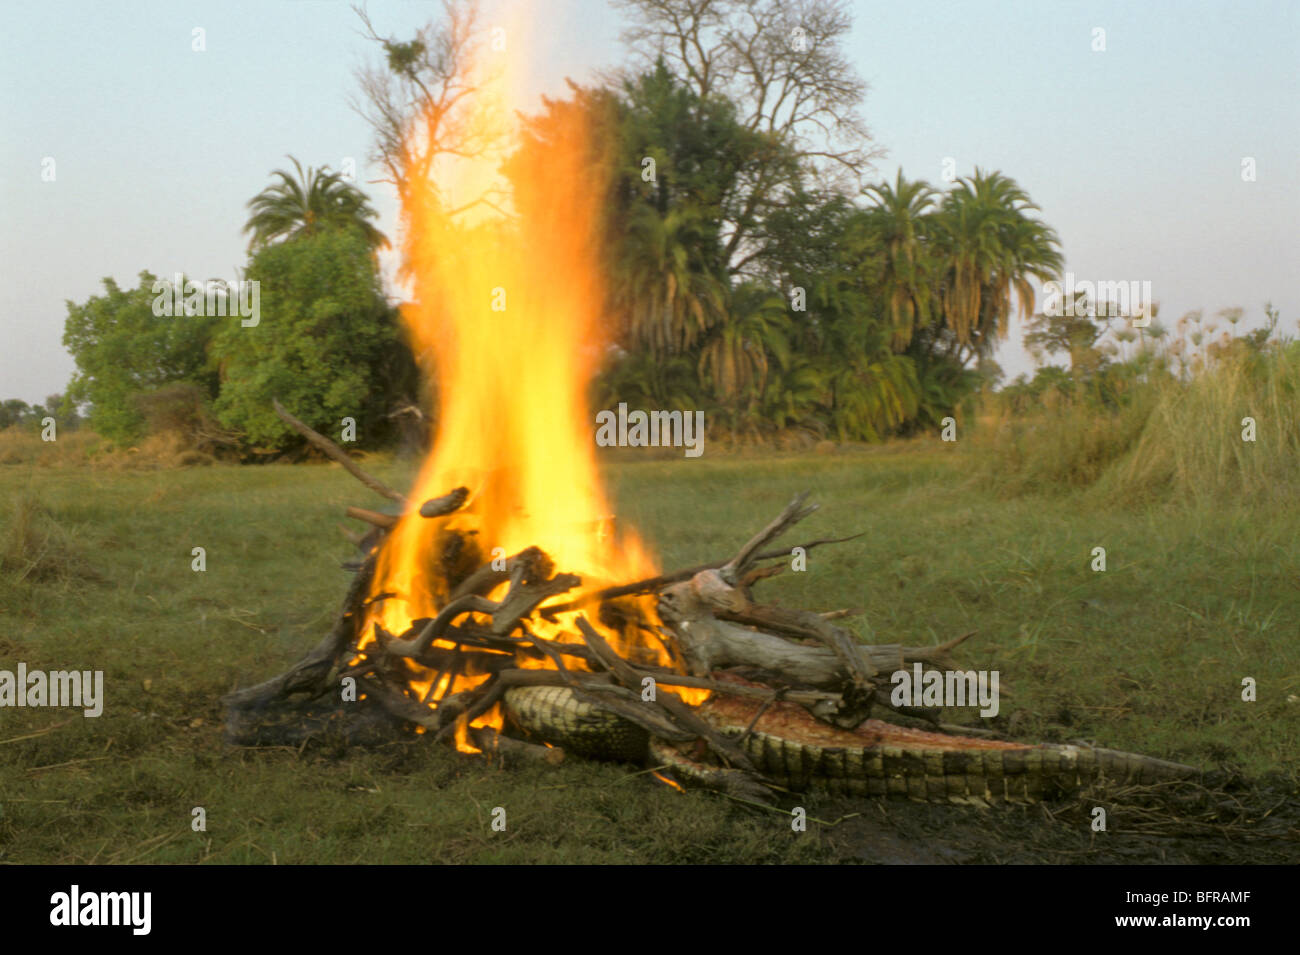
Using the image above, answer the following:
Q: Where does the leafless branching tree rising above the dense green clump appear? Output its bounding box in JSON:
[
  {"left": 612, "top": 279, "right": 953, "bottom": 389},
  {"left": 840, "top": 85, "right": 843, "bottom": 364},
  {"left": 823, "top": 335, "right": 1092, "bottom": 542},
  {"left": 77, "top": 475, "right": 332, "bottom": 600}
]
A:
[{"left": 618, "top": 0, "right": 883, "bottom": 272}]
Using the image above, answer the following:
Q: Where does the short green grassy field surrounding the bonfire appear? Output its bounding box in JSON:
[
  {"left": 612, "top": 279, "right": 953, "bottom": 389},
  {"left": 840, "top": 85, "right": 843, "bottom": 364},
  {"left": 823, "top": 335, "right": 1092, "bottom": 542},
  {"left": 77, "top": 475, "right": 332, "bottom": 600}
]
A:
[{"left": 0, "top": 443, "right": 1300, "bottom": 863}]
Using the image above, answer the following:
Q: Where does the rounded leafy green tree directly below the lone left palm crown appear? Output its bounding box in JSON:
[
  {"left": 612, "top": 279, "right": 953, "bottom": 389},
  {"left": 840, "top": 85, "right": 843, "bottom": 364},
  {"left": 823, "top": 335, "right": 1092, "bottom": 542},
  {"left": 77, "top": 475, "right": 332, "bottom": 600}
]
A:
[{"left": 212, "top": 230, "right": 400, "bottom": 450}]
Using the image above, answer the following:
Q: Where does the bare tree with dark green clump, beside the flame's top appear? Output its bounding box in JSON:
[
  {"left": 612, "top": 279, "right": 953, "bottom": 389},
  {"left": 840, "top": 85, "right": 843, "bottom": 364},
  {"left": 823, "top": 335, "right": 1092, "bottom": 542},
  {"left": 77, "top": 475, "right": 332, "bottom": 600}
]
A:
[{"left": 351, "top": 0, "right": 499, "bottom": 212}]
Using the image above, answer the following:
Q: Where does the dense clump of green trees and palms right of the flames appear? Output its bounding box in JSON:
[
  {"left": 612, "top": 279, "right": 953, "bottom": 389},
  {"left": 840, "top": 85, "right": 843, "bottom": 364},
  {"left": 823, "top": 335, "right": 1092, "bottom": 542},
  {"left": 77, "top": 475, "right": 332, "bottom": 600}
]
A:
[{"left": 501, "top": 62, "right": 1061, "bottom": 440}]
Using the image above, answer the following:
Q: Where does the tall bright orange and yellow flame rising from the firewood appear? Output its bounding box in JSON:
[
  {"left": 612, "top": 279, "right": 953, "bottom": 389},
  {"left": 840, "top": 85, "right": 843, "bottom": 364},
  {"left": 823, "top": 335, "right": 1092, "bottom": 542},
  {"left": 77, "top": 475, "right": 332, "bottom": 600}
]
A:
[{"left": 363, "top": 13, "right": 707, "bottom": 750}]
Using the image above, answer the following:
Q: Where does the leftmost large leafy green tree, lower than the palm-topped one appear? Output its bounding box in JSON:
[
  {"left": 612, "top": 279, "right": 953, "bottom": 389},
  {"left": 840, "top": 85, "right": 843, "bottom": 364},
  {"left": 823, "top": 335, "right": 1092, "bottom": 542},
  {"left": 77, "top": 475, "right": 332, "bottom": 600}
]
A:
[{"left": 64, "top": 272, "right": 219, "bottom": 442}]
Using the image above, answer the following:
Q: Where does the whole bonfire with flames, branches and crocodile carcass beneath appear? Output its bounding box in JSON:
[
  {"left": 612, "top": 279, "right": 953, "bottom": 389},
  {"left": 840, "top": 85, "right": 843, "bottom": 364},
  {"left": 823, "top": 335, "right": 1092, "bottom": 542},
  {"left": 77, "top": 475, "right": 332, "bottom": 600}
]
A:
[{"left": 215, "top": 20, "right": 1192, "bottom": 803}]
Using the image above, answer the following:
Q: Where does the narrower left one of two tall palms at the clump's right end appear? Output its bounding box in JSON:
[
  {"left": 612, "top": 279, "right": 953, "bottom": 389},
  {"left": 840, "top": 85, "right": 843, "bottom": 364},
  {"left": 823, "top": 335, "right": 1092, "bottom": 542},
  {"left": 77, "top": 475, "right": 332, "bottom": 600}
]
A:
[{"left": 866, "top": 169, "right": 935, "bottom": 351}]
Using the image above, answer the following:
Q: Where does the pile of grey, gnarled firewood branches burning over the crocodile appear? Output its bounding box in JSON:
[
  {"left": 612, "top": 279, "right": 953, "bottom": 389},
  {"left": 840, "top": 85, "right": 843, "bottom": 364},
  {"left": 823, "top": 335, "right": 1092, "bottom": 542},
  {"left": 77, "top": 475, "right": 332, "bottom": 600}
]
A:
[{"left": 225, "top": 403, "right": 987, "bottom": 800}]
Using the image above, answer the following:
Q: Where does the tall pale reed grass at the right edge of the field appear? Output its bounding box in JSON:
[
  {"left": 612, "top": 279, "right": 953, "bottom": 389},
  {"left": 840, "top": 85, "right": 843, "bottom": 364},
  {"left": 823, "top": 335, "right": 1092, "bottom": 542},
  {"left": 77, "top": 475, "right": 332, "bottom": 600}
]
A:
[{"left": 967, "top": 342, "right": 1300, "bottom": 500}]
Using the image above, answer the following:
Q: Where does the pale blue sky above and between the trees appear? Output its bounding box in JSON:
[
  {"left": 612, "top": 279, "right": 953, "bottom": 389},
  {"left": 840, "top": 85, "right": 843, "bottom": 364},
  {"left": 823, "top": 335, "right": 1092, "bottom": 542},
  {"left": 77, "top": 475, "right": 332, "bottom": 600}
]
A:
[{"left": 0, "top": 0, "right": 1300, "bottom": 401}]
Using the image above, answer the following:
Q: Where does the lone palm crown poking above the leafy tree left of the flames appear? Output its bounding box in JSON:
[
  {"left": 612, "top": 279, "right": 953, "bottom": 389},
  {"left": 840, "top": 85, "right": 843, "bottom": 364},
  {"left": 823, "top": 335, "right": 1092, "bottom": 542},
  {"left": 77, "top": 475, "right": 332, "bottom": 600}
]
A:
[{"left": 243, "top": 156, "right": 389, "bottom": 249}]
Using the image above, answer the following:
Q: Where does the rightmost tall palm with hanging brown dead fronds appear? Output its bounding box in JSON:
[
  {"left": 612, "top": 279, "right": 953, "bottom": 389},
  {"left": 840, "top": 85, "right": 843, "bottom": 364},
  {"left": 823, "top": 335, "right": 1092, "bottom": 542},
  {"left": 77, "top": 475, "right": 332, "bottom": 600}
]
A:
[{"left": 935, "top": 169, "right": 1062, "bottom": 359}]
